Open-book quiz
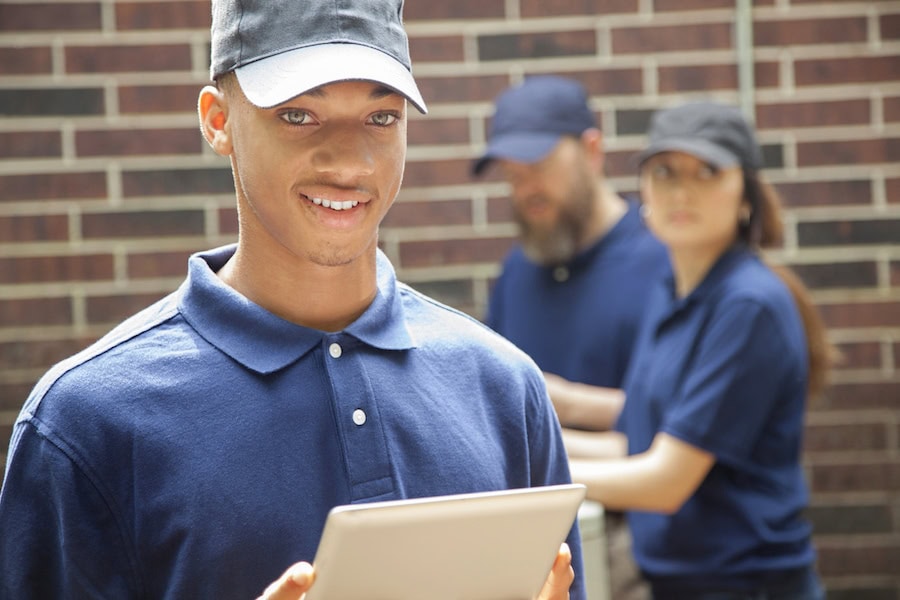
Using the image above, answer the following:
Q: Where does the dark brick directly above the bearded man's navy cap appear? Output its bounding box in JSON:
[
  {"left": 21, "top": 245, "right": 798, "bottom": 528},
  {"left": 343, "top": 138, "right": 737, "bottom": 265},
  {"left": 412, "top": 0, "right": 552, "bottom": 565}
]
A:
[{"left": 478, "top": 29, "right": 597, "bottom": 62}]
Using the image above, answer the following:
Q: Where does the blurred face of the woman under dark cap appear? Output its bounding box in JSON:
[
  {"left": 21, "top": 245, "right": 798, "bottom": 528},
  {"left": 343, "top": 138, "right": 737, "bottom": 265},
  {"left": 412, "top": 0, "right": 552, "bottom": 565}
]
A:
[{"left": 640, "top": 152, "right": 747, "bottom": 257}]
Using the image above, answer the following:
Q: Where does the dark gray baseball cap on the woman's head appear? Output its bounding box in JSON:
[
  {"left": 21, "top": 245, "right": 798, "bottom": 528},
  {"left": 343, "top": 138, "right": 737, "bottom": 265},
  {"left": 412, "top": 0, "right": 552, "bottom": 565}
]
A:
[{"left": 635, "top": 101, "right": 762, "bottom": 171}]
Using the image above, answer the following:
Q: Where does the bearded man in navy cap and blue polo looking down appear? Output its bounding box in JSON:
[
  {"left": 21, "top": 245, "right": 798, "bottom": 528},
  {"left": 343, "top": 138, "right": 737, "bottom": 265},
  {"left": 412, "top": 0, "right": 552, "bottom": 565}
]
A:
[{"left": 473, "top": 76, "right": 668, "bottom": 600}]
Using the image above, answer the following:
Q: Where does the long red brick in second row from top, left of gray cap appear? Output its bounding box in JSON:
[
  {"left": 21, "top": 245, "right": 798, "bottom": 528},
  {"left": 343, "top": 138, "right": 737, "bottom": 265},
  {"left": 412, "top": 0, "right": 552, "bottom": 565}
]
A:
[{"left": 66, "top": 44, "right": 193, "bottom": 73}]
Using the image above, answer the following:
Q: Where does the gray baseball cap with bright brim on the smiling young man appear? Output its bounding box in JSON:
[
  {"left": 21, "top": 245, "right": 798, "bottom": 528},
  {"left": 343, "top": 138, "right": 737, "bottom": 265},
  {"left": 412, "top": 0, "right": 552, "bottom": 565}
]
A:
[{"left": 210, "top": 0, "right": 428, "bottom": 113}]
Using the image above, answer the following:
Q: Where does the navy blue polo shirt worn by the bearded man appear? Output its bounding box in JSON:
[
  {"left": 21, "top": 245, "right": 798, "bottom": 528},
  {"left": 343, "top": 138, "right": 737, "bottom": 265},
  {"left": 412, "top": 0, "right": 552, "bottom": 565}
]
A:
[{"left": 485, "top": 202, "right": 669, "bottom": 388}]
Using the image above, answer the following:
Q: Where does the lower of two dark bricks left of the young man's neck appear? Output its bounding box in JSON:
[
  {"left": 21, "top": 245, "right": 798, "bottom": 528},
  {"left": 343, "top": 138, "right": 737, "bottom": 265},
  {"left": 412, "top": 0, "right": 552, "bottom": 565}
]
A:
[{"left": 81, "top": 210, "right": 204, "bottom": 239}]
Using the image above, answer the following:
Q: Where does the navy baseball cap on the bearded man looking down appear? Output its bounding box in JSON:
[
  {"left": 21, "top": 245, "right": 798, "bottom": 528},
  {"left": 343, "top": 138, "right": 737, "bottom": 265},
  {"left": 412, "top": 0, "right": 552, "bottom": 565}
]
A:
[{"left": 472, "top": 75, "right": 597, "bottom": 175}]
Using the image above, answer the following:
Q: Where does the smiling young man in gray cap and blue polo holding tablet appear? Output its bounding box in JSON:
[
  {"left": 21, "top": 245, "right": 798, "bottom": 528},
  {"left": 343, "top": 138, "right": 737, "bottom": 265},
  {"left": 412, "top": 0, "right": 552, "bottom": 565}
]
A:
[{"left": 0, "top": 0, "right": 583, "bottom": 600}]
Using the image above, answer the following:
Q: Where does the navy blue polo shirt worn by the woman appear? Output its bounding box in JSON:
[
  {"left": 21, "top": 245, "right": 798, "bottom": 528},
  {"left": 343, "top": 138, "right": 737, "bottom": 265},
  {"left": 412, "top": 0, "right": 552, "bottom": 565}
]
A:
[{"left": 617, "top": 247, "right": 814, "bottom": 588}]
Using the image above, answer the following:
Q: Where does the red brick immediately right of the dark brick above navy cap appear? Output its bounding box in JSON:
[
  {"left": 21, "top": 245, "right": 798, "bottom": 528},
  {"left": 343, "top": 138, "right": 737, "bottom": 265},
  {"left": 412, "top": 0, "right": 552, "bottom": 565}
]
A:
[{"left": 612, "top": 23, "right": 732, "bottom": 54}]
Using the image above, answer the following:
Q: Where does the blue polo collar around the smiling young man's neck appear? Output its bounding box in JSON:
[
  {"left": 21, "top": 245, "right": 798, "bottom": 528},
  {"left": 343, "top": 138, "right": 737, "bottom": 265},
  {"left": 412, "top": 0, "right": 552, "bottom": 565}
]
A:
[{"left": 179, "top": 244, "right": 415, "bottom": 373}]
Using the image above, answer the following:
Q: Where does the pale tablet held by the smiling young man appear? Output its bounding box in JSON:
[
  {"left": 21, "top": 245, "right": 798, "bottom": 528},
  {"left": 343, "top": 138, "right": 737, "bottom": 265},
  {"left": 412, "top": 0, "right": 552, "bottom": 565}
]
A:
[{"left": 306, "top": 484, "right": 585, "bottom": 600}]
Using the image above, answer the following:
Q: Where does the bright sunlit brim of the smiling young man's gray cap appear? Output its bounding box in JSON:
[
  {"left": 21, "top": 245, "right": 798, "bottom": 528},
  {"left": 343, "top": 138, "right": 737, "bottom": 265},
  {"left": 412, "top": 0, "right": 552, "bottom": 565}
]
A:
[{"left": 234, "top": 43, "right": 428, "bottom": 114}]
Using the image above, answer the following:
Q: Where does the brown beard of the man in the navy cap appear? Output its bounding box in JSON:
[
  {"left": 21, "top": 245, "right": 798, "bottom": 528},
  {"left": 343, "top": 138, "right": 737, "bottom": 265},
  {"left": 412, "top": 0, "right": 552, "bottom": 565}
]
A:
[{"left": 514, "top": 166, "right": 596, "bottom": 266}]
